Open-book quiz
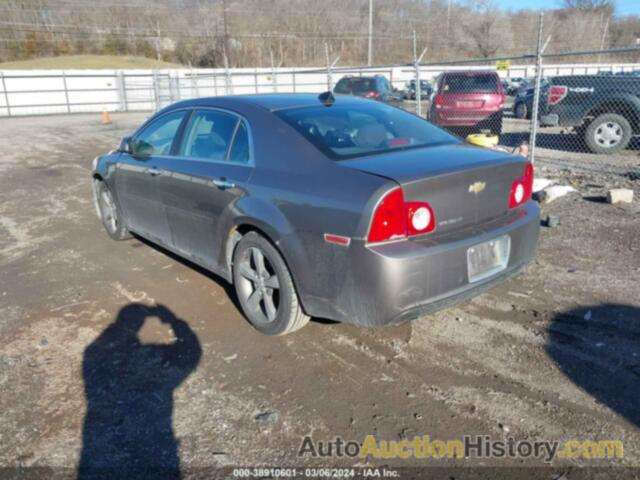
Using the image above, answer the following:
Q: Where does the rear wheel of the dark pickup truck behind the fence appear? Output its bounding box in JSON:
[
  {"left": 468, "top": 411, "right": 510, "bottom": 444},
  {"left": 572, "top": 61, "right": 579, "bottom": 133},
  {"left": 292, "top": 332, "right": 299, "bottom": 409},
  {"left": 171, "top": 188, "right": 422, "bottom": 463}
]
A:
[{"left": 584, "top": 113, "right": 633, "bottom": 153}]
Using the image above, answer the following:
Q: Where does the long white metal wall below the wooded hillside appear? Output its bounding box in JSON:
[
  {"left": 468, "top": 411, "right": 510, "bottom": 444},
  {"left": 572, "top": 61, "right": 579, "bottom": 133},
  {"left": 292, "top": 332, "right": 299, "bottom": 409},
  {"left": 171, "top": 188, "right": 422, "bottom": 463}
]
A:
[{"left": 0, "top": 63, "right": 640, "bottom": 116}]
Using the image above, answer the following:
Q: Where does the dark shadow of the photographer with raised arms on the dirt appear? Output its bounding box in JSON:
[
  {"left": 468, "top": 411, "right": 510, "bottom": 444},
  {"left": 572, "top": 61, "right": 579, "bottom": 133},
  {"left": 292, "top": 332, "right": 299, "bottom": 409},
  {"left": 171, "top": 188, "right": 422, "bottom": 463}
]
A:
[{"left": 78, "top": 304, "right": 202, "bottom": 479}]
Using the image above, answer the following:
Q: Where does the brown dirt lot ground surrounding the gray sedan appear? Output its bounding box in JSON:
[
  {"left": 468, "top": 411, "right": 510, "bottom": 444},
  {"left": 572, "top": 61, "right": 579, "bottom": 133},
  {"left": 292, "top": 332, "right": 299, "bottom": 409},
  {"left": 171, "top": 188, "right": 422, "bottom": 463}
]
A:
[{"left": 0, "top": 114, "right": 640, "bottom": 479}]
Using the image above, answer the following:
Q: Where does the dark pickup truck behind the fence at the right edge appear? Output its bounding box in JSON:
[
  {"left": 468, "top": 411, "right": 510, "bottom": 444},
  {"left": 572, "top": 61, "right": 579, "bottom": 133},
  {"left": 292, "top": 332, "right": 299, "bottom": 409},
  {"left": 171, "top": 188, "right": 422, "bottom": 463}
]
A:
[{"left": 540, "top": 75, "right": 640, "bottom": 153}]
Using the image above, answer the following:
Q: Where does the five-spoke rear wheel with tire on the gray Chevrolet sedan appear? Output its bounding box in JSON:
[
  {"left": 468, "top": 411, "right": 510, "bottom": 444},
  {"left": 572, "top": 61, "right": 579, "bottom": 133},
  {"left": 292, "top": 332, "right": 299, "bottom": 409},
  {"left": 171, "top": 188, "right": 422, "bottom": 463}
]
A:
[{"left": 233, "top": 232, "right": 309, "bottom": 335}]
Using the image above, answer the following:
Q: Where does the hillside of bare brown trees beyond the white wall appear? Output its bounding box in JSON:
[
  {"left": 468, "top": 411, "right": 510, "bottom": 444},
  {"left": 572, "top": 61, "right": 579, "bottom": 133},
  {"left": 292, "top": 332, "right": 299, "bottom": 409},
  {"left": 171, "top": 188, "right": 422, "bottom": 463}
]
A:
[{"left": 0, "top": 0, "right": 640, "bottom": 67}]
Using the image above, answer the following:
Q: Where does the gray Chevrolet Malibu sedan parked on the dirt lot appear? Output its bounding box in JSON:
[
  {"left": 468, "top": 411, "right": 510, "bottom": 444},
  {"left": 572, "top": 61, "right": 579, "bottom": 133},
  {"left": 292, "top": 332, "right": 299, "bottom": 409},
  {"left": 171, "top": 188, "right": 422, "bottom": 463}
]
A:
[{"left": 93, "top": 94, "right": 539, "bottom": 335}]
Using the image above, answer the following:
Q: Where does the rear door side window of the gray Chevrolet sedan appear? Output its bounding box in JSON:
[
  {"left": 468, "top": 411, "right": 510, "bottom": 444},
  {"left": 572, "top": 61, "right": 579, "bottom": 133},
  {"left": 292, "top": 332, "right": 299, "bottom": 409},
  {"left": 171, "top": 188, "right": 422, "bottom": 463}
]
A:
[{"left": 180, "top": 111, "right": 238, "bottom": 160}]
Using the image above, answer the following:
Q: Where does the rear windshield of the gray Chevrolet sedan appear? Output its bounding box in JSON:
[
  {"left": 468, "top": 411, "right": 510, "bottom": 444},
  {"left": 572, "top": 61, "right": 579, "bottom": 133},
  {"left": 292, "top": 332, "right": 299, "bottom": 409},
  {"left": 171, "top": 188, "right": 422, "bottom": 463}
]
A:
[{"left": 274, "top": 101, "right": 459, "bottom": 160}]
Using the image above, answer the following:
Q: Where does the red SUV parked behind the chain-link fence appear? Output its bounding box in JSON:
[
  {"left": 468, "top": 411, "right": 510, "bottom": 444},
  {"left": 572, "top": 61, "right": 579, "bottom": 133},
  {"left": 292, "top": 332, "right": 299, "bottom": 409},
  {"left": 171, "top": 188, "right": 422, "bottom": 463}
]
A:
[{"left": 429, "top": 71, "right": 504, "bottom": 135}]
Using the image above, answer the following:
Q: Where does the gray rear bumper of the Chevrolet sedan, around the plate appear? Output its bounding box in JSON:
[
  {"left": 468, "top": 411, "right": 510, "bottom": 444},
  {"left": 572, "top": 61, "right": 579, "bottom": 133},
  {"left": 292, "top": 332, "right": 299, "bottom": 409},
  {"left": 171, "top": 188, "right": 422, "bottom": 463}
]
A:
[{"left": 334, "top": 201, "right": 540, "bottom": 326}]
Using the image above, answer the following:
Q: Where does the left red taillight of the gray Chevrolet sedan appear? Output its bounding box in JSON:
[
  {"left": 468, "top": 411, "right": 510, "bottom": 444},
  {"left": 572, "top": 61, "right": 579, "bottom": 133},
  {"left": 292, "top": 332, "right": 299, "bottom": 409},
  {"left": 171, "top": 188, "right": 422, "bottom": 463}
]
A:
[{"left": 367, "top": 188, "right": 436, "bottom": 243}]
